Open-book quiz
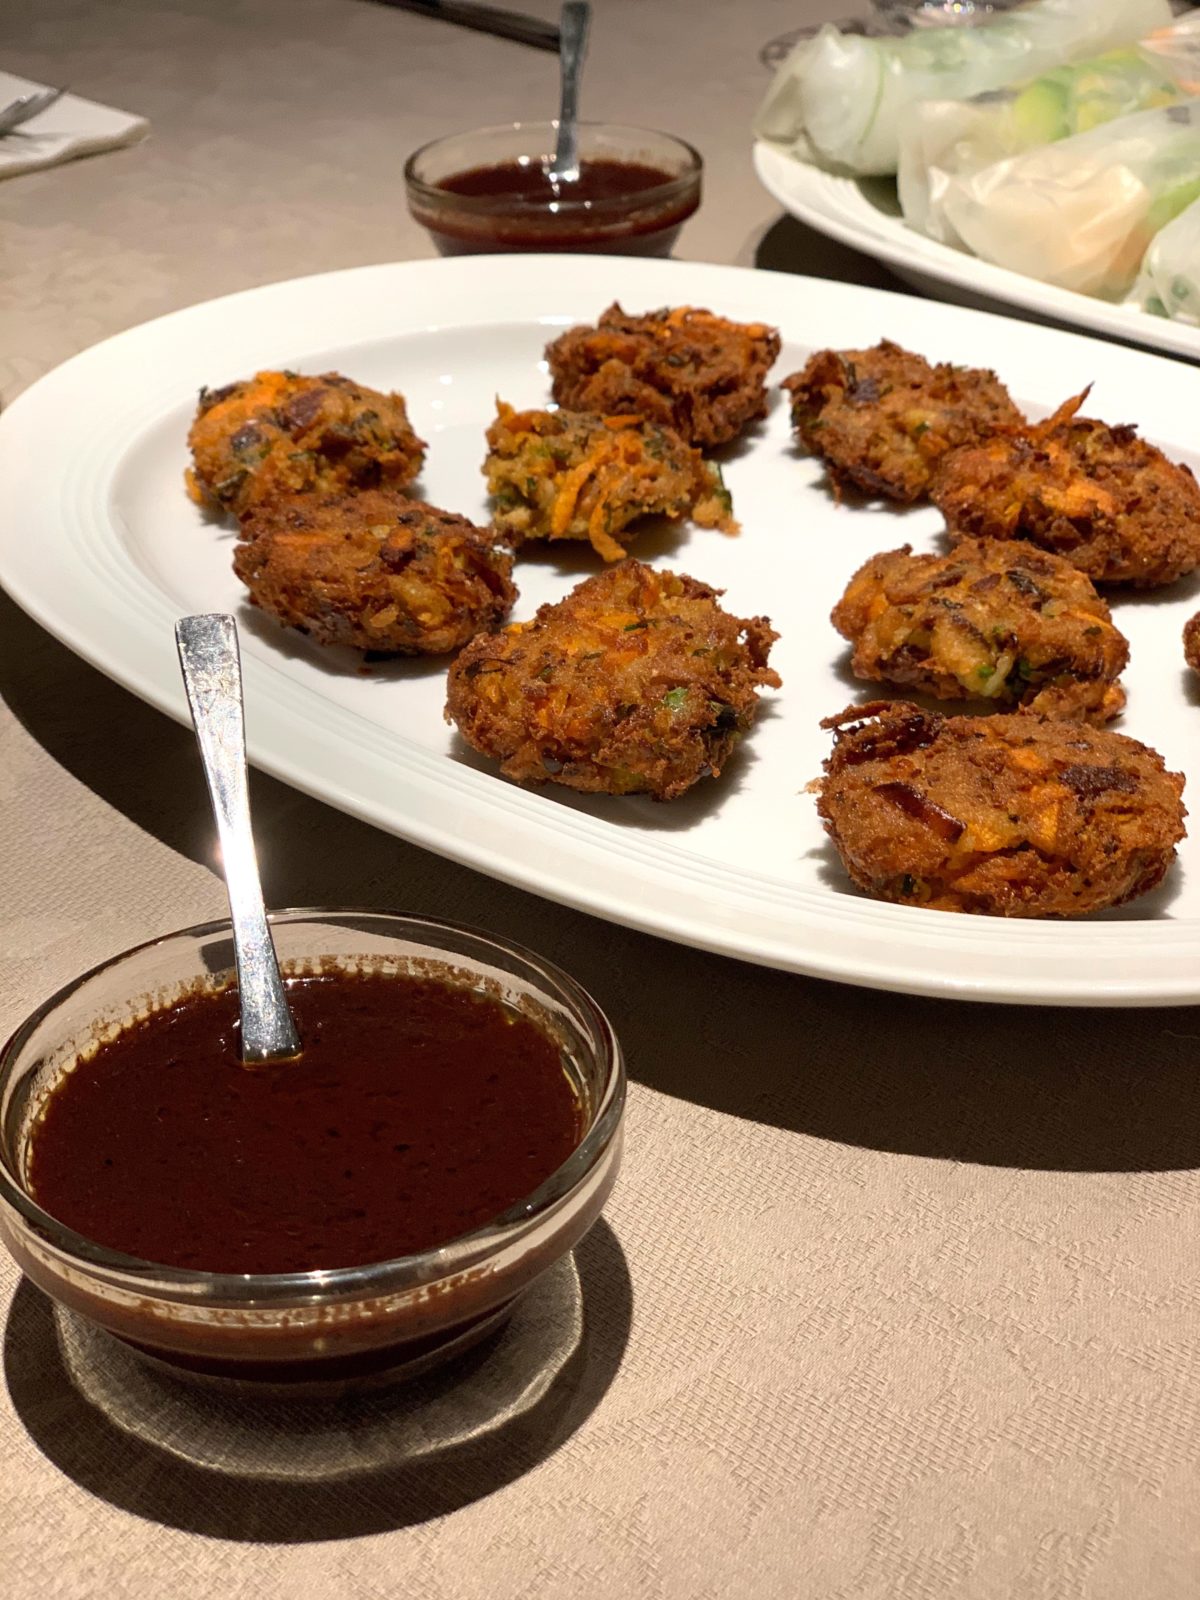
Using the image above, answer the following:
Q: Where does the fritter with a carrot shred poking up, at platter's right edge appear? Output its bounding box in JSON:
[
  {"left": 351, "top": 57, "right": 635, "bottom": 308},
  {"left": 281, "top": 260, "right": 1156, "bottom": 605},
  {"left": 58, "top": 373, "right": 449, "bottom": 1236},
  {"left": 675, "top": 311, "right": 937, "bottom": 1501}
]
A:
[{"left": 931, "top": 390, "right": 1200, "bottom": 589}]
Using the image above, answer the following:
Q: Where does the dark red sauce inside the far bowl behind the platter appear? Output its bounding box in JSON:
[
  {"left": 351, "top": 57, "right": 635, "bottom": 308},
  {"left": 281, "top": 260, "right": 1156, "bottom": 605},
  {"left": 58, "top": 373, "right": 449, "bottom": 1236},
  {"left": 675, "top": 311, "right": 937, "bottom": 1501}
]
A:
[{"left": 410, "top": 158, "right": 699, "bottom": 256}]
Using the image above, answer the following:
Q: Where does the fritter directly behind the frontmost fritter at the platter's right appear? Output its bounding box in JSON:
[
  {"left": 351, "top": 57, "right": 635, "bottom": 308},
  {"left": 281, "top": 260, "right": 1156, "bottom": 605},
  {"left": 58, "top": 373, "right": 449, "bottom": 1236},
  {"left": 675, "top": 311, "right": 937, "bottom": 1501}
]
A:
[{"left": 832, "top": 539, "right": 1130, "bottom": 722}]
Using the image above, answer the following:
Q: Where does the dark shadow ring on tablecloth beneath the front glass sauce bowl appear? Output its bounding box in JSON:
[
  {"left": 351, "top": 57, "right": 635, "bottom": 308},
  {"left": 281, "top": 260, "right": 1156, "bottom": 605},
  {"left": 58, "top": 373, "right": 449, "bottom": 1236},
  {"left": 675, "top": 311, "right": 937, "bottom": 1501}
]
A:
[{"left": 5, "top": 1221, "right": 632, "bottom": 1544}]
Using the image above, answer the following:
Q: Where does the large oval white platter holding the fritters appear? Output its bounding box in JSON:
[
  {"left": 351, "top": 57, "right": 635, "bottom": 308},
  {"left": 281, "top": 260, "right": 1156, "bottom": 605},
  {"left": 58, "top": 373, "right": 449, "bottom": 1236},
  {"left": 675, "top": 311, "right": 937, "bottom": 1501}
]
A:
[{"left": 0, "top": 256, "right": 1200, "bottom": 1003}]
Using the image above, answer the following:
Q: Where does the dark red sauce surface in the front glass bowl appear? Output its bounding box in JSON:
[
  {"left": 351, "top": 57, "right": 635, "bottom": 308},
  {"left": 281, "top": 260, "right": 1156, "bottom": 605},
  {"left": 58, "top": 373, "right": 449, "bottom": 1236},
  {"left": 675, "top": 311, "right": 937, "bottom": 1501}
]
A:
[{"left": 29, "top": 973, "right": 584, "bottom": 1272}]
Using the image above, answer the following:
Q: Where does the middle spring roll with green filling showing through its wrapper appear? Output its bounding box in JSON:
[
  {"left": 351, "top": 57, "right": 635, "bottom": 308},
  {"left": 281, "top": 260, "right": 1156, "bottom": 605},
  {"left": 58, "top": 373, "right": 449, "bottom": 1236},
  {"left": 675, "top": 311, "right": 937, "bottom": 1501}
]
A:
[{"left": 899, "top": 11, "right": 1200, "bottom": 245}]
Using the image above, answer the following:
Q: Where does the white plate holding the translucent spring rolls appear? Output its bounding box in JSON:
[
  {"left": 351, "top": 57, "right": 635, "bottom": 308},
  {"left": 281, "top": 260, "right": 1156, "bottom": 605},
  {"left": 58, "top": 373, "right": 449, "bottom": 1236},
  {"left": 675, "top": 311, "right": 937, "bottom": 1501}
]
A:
[{"left": 754, "top": 139, "right": 1200, "bottom": 362}]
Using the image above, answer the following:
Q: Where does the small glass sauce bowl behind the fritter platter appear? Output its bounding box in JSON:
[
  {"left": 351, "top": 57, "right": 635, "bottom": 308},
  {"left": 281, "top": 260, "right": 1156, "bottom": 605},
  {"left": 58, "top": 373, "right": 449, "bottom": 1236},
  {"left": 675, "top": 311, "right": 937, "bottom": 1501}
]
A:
[{"left": 405, "top": 122, "right": 702, "bottom": 256}]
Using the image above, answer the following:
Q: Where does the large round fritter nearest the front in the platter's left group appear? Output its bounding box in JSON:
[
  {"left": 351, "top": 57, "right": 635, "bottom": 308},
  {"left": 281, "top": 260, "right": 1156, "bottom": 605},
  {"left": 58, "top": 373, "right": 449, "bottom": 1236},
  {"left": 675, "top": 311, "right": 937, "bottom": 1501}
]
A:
[{"left": 446, "top": 562, "right": 779, "bottom": 800}]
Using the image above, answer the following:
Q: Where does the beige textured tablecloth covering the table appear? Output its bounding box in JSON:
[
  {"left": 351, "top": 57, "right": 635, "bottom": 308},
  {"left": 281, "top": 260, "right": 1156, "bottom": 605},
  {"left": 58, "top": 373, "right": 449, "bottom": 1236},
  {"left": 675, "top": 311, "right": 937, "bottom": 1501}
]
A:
[{"left": 0, "top": 0, "right": 1200, "bottom": 1600}]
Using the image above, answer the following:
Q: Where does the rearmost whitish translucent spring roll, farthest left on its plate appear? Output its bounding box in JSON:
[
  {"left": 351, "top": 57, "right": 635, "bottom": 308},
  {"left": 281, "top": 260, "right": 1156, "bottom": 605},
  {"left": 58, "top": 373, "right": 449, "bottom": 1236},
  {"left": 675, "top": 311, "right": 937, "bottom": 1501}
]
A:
[{"left": 755, "top": 0, "right": 1171, "bottom": 174}]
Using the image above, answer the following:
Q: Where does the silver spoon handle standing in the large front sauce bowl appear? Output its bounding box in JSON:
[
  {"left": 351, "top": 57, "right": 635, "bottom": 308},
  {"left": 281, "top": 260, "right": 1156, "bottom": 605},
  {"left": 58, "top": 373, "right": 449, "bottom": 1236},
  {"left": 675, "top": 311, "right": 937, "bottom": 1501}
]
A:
[{"left": 174, "top": 613, "right": 301, "bottom": 1062}]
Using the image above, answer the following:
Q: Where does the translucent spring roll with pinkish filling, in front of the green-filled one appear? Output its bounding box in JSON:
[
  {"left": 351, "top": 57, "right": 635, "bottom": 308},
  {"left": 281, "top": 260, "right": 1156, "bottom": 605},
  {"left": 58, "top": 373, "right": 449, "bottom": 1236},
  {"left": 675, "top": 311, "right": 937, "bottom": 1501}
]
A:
[{"left": 942, "top": 99, "right": 1200, "bottom": 299}]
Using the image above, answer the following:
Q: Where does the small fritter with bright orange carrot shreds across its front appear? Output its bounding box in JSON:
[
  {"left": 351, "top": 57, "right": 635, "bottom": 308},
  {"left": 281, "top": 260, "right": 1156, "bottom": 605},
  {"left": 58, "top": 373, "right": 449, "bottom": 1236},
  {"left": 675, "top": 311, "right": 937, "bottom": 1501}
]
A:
[{"left": 483, "top": 400, "right": 738, "bottom": 562}]
